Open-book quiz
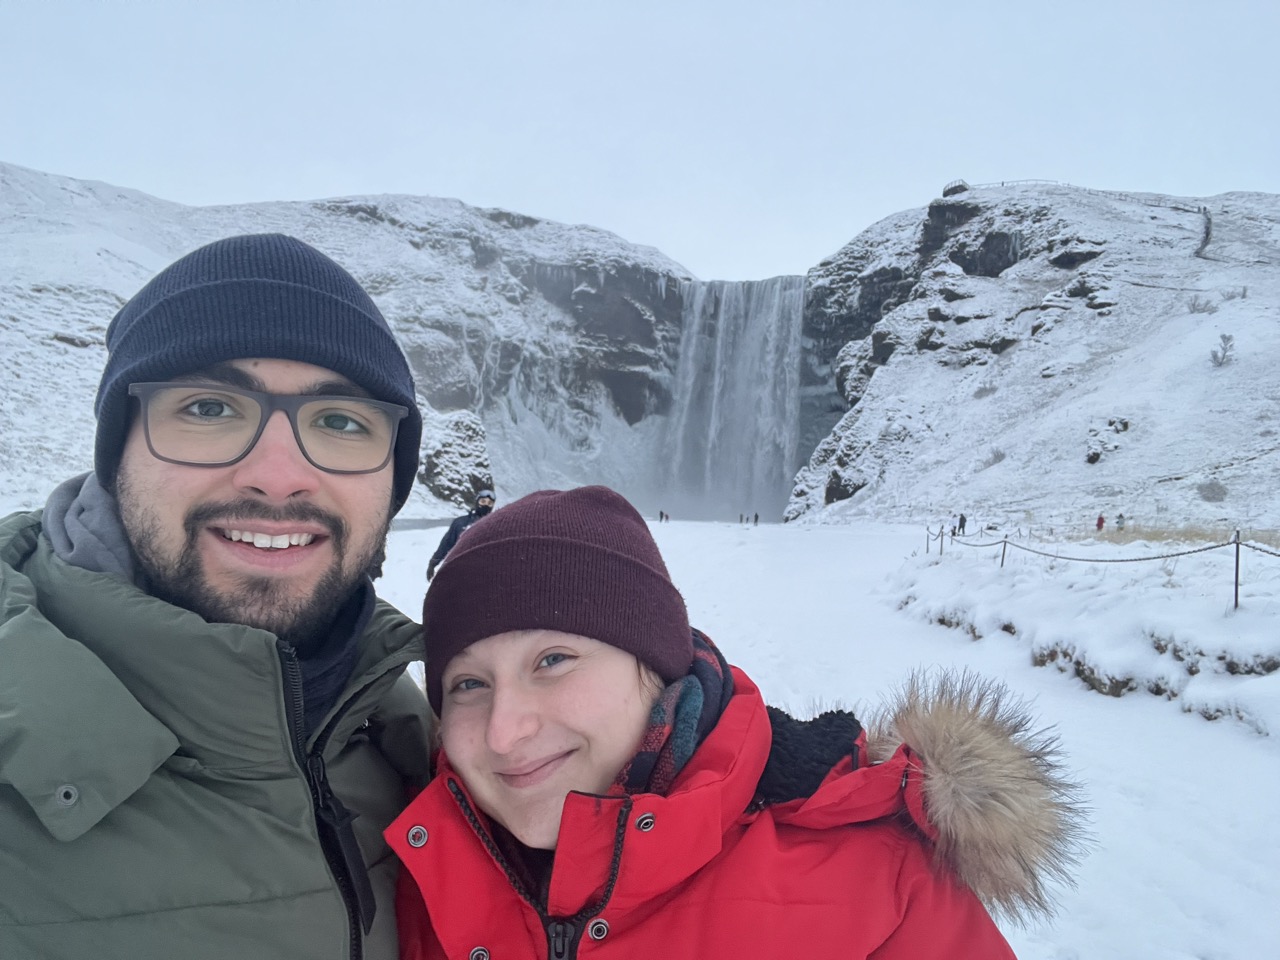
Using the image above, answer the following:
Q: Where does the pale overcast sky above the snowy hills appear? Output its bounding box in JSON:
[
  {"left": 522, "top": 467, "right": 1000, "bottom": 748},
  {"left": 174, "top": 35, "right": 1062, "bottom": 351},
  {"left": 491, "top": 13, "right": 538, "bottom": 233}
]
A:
[{"left": 0, "top": 0, "right": 1280, "bottom": 280}]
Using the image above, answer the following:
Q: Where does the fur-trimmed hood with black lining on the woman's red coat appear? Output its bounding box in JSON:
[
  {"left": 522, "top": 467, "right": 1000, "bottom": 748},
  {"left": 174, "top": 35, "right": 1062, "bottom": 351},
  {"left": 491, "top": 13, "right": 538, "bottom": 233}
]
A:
[{"left": 758, "top": 671, "right": 1088, "bottom": 923}]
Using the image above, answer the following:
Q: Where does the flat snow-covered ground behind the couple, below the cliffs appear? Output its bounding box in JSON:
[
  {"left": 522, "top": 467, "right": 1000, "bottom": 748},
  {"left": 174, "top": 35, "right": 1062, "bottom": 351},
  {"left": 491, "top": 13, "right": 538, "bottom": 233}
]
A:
[{"left": 380, "top": 522, "right": 1280, "bottom": 960}]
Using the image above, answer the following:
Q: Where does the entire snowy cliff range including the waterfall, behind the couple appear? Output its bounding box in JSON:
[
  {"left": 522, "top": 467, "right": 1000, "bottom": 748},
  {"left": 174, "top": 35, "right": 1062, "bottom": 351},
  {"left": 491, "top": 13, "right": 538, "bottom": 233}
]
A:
[{"left": 0, "top": 164, "right": 1280, "bottom": 529}]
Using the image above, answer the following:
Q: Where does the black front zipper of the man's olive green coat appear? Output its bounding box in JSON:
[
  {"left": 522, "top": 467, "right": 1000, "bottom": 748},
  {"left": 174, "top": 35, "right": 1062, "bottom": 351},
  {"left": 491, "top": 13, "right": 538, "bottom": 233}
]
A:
[{"left": 278, "top": 643, "right": 374, "bottom": 960}]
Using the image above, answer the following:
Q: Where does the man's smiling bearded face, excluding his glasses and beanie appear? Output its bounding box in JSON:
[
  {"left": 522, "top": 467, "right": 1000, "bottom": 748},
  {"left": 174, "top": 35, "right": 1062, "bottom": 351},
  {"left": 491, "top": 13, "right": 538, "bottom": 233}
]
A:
[{"left": 116, "top": 360, "right": 394, "bottom": 646}]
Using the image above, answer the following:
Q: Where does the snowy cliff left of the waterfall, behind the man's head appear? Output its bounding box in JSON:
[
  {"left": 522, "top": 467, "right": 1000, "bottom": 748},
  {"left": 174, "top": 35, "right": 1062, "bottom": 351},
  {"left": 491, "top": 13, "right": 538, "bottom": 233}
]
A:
[{"left": 0, "top": 165, "right": 690, "bottom": 515}]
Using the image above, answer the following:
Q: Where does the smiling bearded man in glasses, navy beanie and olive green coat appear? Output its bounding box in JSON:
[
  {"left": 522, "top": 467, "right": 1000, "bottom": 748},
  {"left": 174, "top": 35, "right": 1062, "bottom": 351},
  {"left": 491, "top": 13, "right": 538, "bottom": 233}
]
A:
[{"left": 0, "top": 236, "right": 430, "bottom": 960}]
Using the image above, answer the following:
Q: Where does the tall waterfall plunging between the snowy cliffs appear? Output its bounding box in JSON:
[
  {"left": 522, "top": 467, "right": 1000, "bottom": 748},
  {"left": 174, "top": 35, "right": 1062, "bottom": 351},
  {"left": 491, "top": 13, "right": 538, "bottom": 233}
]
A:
[{"left": 659, "top": 276, "right": 805, "bottom": 521}]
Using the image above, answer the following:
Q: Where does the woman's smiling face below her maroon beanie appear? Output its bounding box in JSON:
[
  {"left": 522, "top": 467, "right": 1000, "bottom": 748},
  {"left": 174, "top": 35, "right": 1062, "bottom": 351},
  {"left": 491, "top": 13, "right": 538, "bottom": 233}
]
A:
[{"left": 440, "top": 630, "right": 662, "bottom": 850}]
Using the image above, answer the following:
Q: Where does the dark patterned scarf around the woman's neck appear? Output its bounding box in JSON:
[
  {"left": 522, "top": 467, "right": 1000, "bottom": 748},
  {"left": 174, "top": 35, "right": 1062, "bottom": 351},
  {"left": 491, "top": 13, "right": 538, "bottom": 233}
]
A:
[{"left": 613, "top": 630, "right": 733, "bottom": 795}]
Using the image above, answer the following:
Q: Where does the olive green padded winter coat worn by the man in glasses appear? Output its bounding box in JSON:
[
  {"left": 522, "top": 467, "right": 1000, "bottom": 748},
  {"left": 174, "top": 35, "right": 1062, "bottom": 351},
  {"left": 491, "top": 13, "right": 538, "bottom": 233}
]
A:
[{"left": 0, "top": 513, "right": 430, "bottom": 960}]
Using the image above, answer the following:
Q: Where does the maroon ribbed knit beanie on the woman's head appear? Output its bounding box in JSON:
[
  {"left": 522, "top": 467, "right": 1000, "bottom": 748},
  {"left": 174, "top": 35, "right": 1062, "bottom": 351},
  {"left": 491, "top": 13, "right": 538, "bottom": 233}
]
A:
[{"left": 422, "top": 486, "right": 694, "bottom": 713}]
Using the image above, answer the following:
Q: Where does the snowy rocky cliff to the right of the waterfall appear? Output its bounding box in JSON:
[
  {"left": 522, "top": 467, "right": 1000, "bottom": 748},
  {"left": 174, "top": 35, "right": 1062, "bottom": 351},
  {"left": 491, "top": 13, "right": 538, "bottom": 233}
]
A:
[{"left": 786, "top": 184, "right": 1280, "bottom": 524}]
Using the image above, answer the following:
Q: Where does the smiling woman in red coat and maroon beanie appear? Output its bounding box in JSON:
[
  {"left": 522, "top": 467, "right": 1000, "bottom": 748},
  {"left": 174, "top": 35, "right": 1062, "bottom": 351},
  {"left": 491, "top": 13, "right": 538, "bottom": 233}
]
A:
[{"left": 387, "top": 486, "right": 1075, "bottom": 960}]
